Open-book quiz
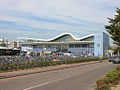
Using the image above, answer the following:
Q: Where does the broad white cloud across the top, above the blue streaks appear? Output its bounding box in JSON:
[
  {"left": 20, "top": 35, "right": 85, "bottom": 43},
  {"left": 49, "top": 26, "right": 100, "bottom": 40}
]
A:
[{"left": 1, "top": 0, "right": 117, "bottom": 23}]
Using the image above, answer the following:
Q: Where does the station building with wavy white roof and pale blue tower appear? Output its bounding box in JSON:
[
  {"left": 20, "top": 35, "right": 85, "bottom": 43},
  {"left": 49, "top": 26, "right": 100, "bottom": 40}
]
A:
[{"left": 18, "top": 32, "right": 109, "bottom": 56}]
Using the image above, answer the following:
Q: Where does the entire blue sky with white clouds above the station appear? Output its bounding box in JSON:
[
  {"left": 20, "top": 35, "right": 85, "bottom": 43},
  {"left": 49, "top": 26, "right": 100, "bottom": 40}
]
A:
[{"left": 0, "top": 0, "right": 120, "bottom": 41}]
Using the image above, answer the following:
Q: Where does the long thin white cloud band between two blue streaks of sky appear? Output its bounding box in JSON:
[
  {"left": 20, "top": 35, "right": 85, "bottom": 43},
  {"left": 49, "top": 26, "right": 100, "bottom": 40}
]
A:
[{"left": 0, "top": 15, "right": 100, "bottom": 33}]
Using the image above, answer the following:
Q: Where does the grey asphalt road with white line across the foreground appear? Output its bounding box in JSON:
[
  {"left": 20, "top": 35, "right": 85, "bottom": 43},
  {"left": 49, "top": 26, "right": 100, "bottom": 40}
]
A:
[{"left": 0, "top": 62, "right": 119, "bottom": 90}]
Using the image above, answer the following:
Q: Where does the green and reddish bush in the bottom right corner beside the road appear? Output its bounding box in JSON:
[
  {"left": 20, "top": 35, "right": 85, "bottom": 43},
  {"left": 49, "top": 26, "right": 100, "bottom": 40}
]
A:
[{"left": 96, "top": 66, "right": 120, "bottom": 90}]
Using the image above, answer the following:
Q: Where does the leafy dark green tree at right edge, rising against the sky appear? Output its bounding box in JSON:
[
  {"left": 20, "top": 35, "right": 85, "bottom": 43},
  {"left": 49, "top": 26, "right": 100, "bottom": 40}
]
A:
[{"left": 105, "top": 8, "right": 120, "bottom": 47}]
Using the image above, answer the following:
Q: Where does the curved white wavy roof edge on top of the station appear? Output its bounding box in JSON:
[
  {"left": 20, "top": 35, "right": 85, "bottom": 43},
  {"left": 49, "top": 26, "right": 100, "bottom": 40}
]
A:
[{"left": 18, "top": 33, "right": 94, "bottom": 42}]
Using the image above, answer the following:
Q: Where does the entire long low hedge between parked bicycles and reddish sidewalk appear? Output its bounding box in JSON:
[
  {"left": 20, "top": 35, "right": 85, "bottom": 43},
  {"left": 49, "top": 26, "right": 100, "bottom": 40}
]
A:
[{"left": 0, "top": 58, "right": 107, "bottom": 72}]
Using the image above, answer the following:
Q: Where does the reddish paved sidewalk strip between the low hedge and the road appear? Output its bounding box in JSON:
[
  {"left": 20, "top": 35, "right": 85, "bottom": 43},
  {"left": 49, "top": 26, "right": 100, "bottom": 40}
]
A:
[{"left": 0, "top": 61, "right": 104, "bottom": 79}]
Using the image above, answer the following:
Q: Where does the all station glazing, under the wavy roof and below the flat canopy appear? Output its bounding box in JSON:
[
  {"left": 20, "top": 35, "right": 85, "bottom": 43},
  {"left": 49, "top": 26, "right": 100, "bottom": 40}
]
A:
[{"left": 20, "top": 34, "right": 94, "bottom": 55}]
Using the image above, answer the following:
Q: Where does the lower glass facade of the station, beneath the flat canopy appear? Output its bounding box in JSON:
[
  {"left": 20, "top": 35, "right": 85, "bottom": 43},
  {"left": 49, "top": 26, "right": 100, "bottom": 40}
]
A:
[{"left": 20, "top": 44, "right": 94, "bottom": 55}]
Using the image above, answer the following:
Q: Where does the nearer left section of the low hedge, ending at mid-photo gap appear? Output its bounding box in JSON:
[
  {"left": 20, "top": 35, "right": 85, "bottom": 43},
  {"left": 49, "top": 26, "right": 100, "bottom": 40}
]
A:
[{"left": 0, "top": 61, "right": 61, "bottom": 72}]
